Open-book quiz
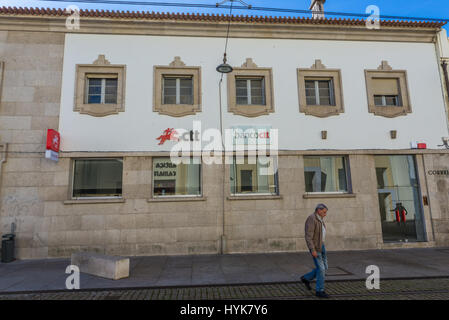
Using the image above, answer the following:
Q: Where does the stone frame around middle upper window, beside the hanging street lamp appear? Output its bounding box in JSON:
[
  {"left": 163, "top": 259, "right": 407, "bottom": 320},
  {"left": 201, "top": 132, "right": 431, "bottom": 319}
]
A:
[{"left": 228, "top": 58, "right": 274, "bottom": 117}]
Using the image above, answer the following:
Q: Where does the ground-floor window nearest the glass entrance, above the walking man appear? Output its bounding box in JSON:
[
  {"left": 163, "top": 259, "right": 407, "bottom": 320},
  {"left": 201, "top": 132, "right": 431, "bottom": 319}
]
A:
[{"left": 304, "top": 156, "right": 351, "bottom": 193}]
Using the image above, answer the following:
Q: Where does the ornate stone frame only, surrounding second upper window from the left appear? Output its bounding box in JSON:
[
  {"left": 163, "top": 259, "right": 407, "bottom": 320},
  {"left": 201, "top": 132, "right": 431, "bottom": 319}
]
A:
[{"left": 153, "top": 56, "right": 202, "bottom": 117}]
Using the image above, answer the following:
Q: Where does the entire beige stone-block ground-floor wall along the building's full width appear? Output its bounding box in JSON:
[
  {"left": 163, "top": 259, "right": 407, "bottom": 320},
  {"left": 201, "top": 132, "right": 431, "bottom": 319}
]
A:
[{"left": 1, "top": 154, "right": 449, "bottom": 258}]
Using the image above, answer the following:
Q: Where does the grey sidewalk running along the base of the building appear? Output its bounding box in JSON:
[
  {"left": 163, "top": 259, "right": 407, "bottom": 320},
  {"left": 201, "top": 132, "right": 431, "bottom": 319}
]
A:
[{"left": 0, "top": 248, "right": 449, "bottom": 293}]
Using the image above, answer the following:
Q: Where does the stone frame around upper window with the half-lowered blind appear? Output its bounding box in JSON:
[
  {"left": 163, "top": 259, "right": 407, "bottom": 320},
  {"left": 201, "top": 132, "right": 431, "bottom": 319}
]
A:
[{"left": 365, "top": 61, "right": 412, "bottom": 118}]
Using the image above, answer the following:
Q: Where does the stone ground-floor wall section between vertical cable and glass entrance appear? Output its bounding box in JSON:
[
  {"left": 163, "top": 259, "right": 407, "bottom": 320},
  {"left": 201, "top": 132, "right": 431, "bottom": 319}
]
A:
[{"left": 225, "top": 155, "right": 382, "bottom": 252}]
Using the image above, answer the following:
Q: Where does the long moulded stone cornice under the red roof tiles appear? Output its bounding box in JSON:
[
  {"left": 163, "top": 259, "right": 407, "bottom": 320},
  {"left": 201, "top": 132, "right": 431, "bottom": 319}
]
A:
[{"left": 0, "top": 7, "right": 444, "bottom": 43}]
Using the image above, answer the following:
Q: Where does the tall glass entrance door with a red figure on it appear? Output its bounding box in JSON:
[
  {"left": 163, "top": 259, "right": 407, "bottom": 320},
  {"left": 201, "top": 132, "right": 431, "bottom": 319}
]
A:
[{"left": 375, "top": 155, "right": 426, "bottom": 242}]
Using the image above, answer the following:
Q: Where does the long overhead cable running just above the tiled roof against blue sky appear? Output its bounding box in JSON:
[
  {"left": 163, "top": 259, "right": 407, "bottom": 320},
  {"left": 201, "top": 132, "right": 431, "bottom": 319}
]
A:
[{"left": 34, "top": 0, "right": 449, "bottom": 22}]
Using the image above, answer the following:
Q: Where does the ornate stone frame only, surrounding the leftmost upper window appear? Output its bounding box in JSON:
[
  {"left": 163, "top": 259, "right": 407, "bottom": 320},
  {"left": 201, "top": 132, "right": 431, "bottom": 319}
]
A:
[{"left": 73, "top": 54, "right": 126, "bottom": 117}]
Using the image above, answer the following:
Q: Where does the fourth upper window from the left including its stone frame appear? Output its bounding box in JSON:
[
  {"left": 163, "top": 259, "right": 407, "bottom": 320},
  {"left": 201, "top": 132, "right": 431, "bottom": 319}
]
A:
[{"left": 297, "top": 60, "right": 344, "bottom": 117}]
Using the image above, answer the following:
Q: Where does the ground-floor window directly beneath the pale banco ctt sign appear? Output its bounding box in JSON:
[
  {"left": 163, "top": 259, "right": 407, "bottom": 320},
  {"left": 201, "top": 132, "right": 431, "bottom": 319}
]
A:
[{"left": 231, "top": 156, "right": 278, "bottom": 195}]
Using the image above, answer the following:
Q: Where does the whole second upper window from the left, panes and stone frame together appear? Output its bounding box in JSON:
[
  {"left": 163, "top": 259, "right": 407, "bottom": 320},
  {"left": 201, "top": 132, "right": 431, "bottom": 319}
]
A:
[{"left": 153, "top": 57, "right": 201, "bottom": 117}]
